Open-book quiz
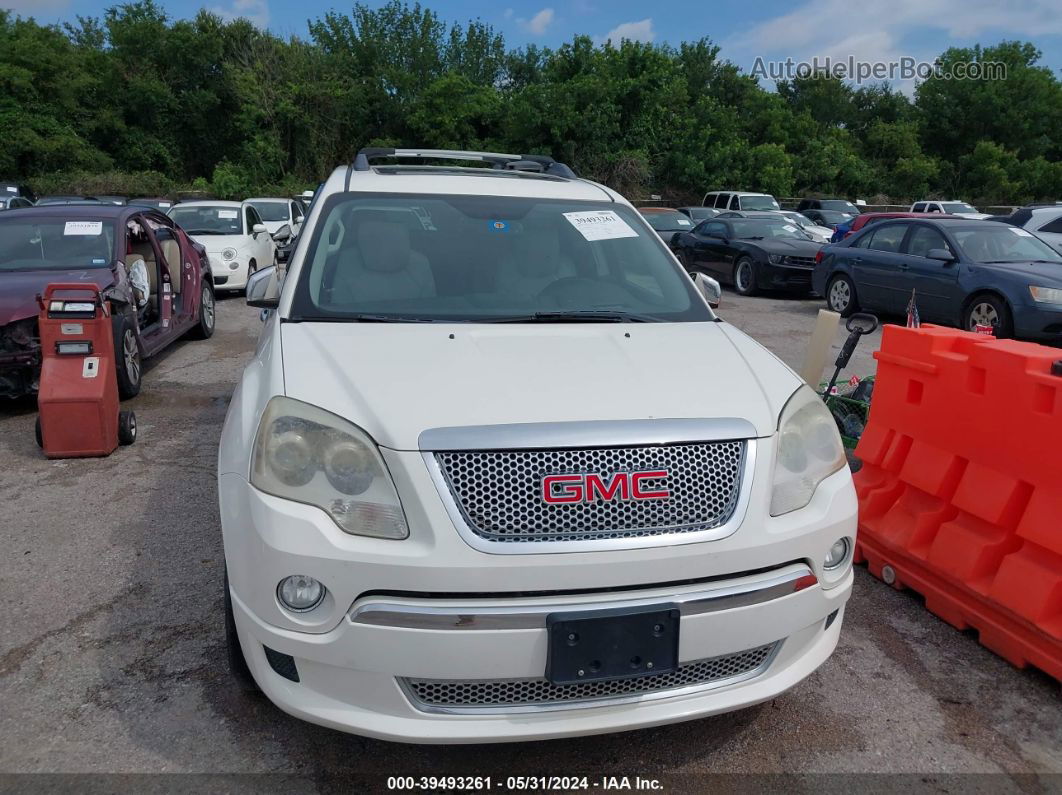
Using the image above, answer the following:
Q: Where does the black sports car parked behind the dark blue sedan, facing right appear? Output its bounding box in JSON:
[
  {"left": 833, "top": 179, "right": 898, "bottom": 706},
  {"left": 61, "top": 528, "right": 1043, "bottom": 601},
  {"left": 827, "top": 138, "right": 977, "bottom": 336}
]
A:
[{"left": 672, "top": 217, "right": 822, "bottom": 295}]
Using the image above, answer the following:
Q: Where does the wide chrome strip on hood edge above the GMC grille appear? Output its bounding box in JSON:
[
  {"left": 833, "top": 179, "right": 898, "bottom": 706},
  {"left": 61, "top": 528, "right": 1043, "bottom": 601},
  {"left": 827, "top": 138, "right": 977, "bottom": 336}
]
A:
[{"left": 417, "top": 417, "right": 757, "bottom": 452}]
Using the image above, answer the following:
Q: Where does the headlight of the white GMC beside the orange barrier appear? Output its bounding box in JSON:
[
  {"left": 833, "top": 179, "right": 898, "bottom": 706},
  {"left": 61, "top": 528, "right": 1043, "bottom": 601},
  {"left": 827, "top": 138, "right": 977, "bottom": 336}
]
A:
[{"left": 771, "top": 384, "right": 845, "bottom": 516}]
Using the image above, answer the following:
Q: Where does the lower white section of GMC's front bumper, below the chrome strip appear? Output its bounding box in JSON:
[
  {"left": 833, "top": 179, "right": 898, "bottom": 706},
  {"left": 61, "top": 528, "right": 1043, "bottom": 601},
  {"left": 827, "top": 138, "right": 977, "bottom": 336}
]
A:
[{"left": 233, "top": 569, "right": 853, "bottom": 743}]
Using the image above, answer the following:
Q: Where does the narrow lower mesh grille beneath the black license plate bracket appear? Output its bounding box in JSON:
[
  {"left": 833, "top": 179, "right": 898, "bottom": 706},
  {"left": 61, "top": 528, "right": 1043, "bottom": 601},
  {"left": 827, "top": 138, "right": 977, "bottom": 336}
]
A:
[{"left": 401, "top": 643, "right": 777, "bottom": 709}]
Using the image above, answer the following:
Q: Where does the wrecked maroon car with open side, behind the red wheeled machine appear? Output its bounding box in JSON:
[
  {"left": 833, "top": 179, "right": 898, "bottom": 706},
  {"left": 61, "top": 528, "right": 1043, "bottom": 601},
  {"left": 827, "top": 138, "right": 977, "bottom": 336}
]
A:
[{"left": 0, "top": 204, "right": 215, "bottom": 398}]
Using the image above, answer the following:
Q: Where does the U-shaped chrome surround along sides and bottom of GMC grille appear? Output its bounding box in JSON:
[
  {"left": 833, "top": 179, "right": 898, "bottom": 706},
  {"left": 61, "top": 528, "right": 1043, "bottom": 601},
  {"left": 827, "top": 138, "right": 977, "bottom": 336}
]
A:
[{"left": 421, "top": 435, "right": 756, "bottom": 555}]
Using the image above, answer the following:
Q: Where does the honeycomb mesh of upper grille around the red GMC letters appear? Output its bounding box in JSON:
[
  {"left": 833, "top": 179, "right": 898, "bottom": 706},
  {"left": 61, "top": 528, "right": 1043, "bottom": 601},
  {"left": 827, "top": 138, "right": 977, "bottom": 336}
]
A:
[{"left": 435, "top": 442, "right": 746, "bottom": 541}]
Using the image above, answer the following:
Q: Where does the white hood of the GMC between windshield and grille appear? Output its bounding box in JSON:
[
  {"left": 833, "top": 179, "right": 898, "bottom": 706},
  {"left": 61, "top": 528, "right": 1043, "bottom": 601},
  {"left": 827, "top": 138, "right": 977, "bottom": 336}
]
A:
[{"left": 281, "top": 323, "right": 801, "bottom": 450}]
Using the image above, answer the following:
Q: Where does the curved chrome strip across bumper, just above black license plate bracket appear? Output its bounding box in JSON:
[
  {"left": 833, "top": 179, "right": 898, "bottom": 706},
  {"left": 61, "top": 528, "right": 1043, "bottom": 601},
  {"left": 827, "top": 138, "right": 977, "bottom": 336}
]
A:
[{"left": 348, "top": 564, "right": 818, "bottom": 630}]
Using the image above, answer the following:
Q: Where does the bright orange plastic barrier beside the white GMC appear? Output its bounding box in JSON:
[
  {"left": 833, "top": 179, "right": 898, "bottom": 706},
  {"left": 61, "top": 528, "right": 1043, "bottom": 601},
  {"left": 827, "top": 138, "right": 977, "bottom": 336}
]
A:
[{"left": 855, "top": 326, "right": 1062, "bottom": 680}]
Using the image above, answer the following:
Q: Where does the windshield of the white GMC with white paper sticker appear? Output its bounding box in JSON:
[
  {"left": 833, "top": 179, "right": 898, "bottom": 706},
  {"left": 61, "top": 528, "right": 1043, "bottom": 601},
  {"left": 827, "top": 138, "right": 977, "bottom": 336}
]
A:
[{"left": 290, "top": 194, "right": 713, "bottom": 323}]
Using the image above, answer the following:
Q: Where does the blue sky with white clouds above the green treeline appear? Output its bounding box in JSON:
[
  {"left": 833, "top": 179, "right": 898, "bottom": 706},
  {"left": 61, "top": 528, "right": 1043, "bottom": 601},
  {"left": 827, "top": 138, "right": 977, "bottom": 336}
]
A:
[{"left": 8, "top": 0, "right": 1062, "bottom": 87}]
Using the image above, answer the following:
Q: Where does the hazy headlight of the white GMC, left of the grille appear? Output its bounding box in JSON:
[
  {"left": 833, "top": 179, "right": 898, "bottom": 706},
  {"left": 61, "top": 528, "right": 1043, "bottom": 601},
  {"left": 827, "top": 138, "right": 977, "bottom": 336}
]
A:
[{"left": 251, "top": 396, "right": 409, "bottom": 538}]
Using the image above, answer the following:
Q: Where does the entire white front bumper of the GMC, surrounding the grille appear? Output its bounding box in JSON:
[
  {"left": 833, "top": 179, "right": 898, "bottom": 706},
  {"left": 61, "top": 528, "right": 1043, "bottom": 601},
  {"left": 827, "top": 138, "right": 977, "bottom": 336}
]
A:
[{"left": 219, "top": 440, "right": 856, "bottom": 743}]
